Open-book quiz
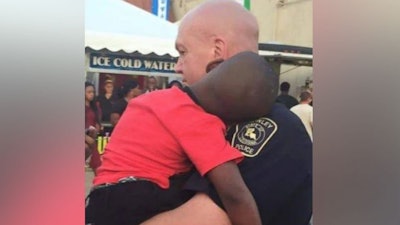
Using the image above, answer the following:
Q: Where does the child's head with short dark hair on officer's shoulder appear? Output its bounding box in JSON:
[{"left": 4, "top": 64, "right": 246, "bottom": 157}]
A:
[{"left": 189, "top": 52, "right": 279, "bottom": 123}]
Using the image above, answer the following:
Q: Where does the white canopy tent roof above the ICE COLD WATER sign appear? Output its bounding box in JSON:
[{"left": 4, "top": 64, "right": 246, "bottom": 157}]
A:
[{"left": 85, "top": 0, "right": 178, "bottom": 56}]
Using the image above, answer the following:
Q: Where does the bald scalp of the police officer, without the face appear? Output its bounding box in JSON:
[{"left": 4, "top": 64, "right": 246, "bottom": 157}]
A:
[{"left": 179, "top": 0, "right": 259, "bottom": 59}]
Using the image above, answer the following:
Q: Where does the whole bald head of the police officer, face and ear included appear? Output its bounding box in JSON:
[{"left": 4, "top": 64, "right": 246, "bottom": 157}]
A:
[{"left": 175, "top": 0, "right": 258, "bottom": 85}]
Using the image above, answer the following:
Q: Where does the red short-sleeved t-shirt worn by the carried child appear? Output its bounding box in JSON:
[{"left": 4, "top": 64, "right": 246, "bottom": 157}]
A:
[{"left": 93, "top": 87, "right": 243, "bottom": 188}]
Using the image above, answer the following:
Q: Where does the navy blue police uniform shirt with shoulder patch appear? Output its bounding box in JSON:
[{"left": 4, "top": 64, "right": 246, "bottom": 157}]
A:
[{"left": 186, "top": 103, "right": 312, "bottom": 225}]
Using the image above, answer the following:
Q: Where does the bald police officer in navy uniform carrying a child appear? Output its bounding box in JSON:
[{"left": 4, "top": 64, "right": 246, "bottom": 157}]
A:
[{"left": 142, "top": 0, "right": 312, "bottom": 225}]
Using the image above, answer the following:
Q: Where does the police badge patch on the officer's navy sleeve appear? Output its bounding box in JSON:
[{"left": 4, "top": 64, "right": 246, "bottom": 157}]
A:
[{"left": 231, "top": 117, "right": 278, "bottom": 157}]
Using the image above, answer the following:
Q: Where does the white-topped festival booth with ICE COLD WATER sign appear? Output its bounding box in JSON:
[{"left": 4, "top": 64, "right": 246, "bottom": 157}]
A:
[{"left": 85, "top": 0, "right": 181, "bottom": 93}]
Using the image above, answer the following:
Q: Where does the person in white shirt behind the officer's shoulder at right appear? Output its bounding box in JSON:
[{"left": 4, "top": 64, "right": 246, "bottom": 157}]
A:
[{"left": 290, "top": 91, "right": 313, "bottom": 141}]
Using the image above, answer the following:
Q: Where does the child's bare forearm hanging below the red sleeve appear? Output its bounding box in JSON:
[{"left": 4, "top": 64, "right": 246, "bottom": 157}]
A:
[{"left": 207, "top": 161, "right": 262, "bottom": 225}]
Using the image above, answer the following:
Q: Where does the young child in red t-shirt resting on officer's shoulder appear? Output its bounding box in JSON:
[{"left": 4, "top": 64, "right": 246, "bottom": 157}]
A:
[{"left": 86, "top": 52, "right": 278, "bottom": 225}]
